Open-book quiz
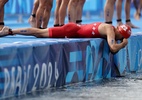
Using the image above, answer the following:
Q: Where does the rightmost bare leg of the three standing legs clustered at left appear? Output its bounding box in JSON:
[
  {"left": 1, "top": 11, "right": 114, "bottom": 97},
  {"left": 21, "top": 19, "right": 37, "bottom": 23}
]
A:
[{"left": 42, "top": 0, "right": 53, "bottom": 28}]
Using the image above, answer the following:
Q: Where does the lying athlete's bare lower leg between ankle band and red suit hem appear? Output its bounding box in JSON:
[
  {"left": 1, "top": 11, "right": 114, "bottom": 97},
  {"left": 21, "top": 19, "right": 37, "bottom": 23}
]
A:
[{"left": 12, "top": 28, "right": 49, "bottom": 38}]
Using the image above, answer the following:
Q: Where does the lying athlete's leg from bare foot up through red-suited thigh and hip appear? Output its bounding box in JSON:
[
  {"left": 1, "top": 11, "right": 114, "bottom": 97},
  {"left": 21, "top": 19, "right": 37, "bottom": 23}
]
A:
[{"left": 0, "top": 23, "right": 81, "bottom": 38}]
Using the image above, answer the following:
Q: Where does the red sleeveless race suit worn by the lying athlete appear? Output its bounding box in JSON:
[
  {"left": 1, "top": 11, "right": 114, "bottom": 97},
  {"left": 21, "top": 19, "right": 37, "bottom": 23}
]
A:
[{"left": 49, "top": 22, "right": 102, "bottom": 38}]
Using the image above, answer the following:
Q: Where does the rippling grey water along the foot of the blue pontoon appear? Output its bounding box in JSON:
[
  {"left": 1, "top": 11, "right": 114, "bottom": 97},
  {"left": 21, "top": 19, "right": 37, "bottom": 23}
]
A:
[{"left": 7, "top": 73, "right": 142, "bottom": 100}]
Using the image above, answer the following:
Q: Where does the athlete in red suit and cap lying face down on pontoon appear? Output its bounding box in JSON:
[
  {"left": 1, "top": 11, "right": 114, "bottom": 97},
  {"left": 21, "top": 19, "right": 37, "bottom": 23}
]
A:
[{"left": 0, "top": 22, "right": 131, "bottom": 53}]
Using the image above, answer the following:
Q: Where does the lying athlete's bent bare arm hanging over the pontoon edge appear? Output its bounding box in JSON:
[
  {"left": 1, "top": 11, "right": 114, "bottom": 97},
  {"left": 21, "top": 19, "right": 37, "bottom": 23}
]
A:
[{"left": 107, "top": 27, "right": 128, "bottom": 53}]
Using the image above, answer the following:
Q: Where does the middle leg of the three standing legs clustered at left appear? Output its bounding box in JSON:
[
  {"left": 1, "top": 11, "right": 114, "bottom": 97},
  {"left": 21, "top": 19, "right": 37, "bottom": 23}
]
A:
[{"left": 36, "top": 0, "right": 47, "bottom": 28}]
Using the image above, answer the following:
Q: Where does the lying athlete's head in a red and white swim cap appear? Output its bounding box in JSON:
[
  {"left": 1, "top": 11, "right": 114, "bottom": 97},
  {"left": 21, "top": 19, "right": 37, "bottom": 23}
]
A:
[{"left": 118, "top": 24, "right": 131, "bottom": 38}]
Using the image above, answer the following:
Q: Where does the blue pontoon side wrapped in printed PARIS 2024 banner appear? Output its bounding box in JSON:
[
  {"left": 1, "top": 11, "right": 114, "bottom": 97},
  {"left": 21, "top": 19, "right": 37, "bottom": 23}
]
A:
[{"left": 0, "top": 35, "right": 142, "bottom": 98}]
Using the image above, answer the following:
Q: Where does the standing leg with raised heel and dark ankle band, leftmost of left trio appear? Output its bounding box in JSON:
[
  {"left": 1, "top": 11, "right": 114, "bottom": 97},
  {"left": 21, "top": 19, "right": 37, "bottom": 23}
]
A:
[{"left": 28, "top": 0, "right": 39, "bottom": 27}]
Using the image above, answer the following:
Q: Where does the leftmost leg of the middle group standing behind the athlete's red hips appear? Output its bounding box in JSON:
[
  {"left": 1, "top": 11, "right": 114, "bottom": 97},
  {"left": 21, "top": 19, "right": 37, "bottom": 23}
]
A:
[{"left": 54, "top": 0, "right": 62, "bottom": 27}]
